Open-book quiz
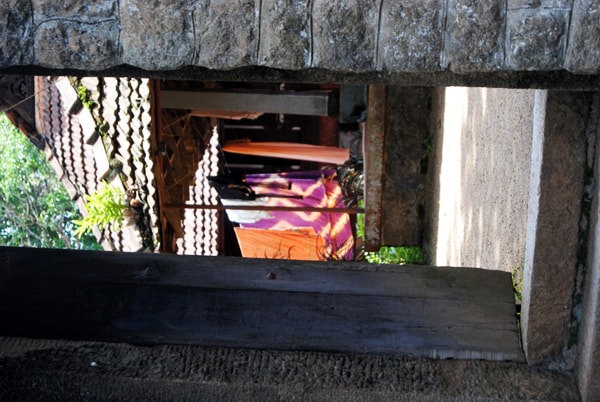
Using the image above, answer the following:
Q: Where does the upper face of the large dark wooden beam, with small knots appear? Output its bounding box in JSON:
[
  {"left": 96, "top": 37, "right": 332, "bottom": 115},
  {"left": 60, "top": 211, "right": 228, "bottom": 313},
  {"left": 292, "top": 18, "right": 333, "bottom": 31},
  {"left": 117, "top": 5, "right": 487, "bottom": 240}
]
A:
[{"left": 0, "top": 247, "right": 513, "bottom": 300}]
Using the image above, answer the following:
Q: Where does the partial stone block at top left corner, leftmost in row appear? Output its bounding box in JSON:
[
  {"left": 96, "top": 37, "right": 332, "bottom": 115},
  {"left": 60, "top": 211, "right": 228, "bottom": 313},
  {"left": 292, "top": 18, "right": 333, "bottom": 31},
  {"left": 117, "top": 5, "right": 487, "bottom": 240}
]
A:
[{"left": 0, "top": 0, "right": 33, "bottom": 67}]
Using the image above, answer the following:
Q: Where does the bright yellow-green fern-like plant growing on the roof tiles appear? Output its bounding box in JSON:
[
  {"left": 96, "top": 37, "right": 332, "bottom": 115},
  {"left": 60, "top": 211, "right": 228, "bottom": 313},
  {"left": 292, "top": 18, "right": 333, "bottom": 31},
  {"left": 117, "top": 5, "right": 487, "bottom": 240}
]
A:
[{"left": 74, "top": 182, "right": 127, "bottom": 237}]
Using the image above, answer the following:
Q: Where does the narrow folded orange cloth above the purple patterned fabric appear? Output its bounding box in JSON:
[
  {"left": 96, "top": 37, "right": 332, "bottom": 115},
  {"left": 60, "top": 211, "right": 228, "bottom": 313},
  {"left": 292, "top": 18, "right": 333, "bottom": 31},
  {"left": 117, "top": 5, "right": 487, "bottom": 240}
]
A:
[{"left": 223, "top": 142, "right": 350, "bottom": 165}]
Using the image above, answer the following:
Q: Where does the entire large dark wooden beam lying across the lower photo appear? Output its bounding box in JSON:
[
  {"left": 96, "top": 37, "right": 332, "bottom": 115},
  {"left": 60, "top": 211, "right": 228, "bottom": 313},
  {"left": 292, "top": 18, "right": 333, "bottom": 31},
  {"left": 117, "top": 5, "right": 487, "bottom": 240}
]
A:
[{"left": 0, "top": 248, "right": 522, "bottom": 361}]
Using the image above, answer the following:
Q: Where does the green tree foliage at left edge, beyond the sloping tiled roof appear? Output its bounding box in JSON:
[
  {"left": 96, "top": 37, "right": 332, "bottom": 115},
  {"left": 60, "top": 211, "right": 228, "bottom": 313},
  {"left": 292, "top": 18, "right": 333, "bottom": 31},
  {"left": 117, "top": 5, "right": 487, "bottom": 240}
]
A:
[{"left": 0, "top": 113, "right": 100, "bottom": 249}]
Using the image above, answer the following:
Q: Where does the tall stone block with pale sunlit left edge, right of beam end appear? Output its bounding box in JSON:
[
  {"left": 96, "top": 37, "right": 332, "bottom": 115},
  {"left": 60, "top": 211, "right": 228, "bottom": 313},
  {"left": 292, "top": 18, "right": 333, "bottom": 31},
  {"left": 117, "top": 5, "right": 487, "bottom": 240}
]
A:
[{"left": 521, "top": 91, "right": 591, "bottom": 364}]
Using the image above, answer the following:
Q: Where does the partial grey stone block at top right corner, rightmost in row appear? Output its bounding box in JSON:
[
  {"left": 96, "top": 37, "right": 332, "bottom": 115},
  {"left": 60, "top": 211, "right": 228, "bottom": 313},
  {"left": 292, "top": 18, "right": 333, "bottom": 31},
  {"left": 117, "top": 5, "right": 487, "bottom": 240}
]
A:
[{"left": 565, "top": 0, "right": 600, "bottom": 74}]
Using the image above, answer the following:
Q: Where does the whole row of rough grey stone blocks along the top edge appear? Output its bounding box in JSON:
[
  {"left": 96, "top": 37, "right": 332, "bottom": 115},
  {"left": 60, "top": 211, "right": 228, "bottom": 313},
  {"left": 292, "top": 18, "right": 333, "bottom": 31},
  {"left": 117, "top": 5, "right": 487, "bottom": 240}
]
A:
[{"left": 0, "top": 0, "right": 600, "bottom": 78}]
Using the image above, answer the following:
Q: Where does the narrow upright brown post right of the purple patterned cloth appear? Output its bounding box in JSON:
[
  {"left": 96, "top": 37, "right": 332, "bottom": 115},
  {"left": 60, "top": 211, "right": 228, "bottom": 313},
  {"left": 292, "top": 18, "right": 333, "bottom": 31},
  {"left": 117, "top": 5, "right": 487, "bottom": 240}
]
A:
[{"left": 363, "top": 85, "right": 387, "bottom": 251}]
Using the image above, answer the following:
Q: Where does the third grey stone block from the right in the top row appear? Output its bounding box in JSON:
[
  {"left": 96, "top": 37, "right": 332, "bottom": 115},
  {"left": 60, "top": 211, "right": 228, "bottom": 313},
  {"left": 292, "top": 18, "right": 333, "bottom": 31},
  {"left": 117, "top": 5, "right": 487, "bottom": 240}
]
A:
[{"left": 441, "top": 0, "right": 505, "bottom": 73}]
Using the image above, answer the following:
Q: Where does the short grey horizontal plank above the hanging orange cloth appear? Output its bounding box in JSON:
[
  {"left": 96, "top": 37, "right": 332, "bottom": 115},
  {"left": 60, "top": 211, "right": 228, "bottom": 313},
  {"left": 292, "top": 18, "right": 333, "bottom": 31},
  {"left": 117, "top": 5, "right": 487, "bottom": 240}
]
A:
[{"left": 160, "top": 90, "right": 338, "bottom": 116}]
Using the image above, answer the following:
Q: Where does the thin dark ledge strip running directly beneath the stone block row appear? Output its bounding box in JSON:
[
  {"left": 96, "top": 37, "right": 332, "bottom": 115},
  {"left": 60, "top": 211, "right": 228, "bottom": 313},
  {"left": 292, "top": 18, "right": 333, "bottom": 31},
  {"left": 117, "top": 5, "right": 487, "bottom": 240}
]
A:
[{"left": 0, "top": 64, "right": 600, "bottom": 91}]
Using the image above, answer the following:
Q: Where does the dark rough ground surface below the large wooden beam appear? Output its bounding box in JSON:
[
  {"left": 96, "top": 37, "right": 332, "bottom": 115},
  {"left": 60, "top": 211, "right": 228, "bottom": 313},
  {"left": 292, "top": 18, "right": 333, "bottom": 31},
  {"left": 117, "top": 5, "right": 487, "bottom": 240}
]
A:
[{"left": 0, "top": 338, "right": 579, "bottom": 401}]
